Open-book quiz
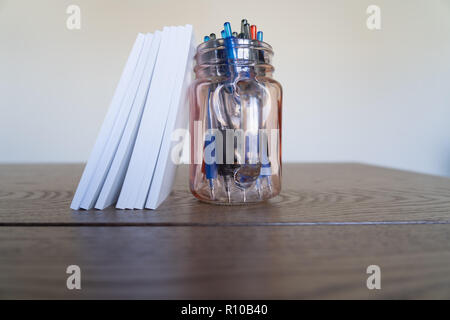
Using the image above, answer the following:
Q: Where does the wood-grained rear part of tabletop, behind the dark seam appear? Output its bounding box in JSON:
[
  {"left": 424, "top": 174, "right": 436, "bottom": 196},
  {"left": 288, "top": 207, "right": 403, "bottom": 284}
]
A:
[{"left": 0, "top": 164, "right": 450, "bottom": 226}]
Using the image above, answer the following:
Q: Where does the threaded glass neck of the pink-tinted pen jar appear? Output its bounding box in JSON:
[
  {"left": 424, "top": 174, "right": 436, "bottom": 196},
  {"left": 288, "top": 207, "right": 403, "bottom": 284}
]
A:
[{"left": 194, "top": 38, "right": 274, "bottom": 79}]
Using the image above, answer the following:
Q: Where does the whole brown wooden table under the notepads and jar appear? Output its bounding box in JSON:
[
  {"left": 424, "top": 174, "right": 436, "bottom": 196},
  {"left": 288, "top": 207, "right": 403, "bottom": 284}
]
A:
[{"left": 0, "top": 164, "right": 450, "bottom": 299}]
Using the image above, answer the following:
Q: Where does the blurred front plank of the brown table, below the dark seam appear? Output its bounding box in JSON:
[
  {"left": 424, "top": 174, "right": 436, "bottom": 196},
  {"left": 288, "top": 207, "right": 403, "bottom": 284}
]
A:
[{"left": 0, "top": 225, "right": 450, "bottom": 299}]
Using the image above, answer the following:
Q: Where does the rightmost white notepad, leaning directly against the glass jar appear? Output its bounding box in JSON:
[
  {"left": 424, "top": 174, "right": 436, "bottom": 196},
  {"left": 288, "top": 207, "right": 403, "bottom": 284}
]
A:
[{"left": 145, "top": 26, "right": 195, "bottom": 209}]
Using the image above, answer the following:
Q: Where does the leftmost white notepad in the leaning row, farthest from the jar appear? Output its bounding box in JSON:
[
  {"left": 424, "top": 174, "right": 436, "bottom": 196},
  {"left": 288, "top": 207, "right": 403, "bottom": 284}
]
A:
[{"left": 70, "top": 34, "right": 145, "bottom": 210}]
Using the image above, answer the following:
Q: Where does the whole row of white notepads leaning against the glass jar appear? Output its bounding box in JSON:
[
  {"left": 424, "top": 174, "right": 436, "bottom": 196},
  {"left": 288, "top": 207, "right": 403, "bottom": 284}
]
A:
[{"left": 70, "top": 25, "right": 195, "bottom": 210}]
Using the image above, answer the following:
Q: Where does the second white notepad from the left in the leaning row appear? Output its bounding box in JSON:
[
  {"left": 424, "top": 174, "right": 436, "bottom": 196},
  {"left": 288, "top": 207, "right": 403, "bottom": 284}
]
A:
[{"left": 95, "top": 31, "right": 161, "bottom": 210}]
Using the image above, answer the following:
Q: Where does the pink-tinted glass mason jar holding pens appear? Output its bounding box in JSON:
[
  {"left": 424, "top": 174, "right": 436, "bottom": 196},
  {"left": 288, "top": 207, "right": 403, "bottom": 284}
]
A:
[{"left": 189, "top": 38, "right": 282, "bottom": 204}]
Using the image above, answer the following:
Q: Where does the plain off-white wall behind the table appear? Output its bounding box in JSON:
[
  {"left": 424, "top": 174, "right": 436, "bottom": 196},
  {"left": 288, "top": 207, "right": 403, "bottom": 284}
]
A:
[{"left": 0, "top": 0, "right": 450, "bottom": 176}]
